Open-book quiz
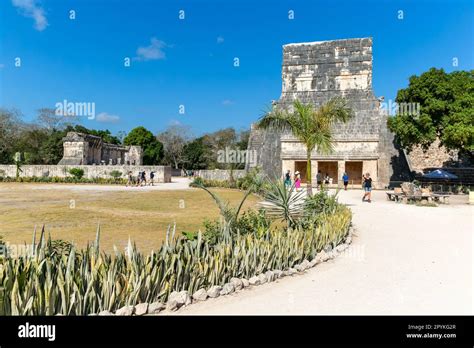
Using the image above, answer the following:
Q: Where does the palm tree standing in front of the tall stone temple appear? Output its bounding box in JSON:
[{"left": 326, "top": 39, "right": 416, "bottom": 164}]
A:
[{"left": 257, "top": 97, "right": 353, "bottom": 195}]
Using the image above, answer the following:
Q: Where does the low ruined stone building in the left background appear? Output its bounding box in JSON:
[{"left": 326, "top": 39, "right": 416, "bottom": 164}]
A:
[{"left": 58, "top": 132, "right": 143, "bottom": 165}]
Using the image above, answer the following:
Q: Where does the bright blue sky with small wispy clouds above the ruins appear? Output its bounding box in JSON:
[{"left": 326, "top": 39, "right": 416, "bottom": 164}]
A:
[{"left": 0, "top": 0, "right": 474, "bottom": 135}]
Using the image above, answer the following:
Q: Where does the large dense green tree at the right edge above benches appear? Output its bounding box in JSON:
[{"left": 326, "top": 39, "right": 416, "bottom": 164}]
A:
[{"left": 388, "top": 68, "right": 474, "bottom": 158}]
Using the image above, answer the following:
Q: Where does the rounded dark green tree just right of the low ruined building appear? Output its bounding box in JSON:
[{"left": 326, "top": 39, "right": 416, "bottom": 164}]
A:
[{"left": 123, "top": 126, "right": 164, "bottom": 165}]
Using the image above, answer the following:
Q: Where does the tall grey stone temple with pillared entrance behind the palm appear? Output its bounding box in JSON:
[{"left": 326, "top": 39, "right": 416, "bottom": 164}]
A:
[{"left": 247, "top": 38, "right": 410, "bottom": 188}]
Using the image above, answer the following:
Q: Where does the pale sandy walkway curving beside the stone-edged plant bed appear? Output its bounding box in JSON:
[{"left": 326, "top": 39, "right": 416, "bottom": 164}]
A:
[{"left": 177, "top": 191, "right": 474, "bottom": 314}]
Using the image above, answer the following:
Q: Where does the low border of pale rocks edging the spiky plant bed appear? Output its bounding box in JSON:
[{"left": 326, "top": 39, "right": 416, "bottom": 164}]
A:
[{"left": 98, "top": 226, "right": 353, "bottom": 315}]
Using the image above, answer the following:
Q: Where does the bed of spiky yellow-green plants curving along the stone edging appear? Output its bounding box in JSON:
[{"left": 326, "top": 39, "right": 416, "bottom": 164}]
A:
[{"left": 0, "top": 184, "right": 351, "bottom": 315}]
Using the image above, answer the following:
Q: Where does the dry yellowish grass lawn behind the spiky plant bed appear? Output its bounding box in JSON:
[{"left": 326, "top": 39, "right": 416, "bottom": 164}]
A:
[{"left": 0, "top": 183, "right": 257, "bottom": 252}]
